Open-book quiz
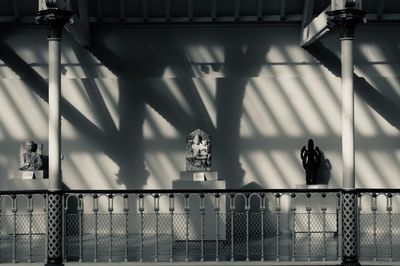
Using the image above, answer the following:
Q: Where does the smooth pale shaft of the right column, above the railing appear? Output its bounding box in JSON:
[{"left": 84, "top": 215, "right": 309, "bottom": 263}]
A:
[{"left": 340, "top": 37, "right": 355, "bottom": 189}]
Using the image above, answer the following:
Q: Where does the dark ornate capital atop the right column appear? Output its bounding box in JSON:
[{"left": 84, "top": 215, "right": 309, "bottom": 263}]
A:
[{"left": 326, "top": 8, "right": 366, "bottom": 39}]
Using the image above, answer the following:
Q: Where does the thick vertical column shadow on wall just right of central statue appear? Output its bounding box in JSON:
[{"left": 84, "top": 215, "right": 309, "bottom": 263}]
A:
[{"left": 216, "top": 41, "right": 269, "bottom": 188}]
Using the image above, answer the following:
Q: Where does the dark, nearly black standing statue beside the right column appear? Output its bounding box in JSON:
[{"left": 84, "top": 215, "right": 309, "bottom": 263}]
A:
[{"left": 300, "top": 139, "right": 321, "bottom": 185}]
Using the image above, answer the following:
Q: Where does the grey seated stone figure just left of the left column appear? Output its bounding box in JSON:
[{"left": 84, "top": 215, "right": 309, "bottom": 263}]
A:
[{"left": 19, "top": 140, "right": 43, "bottom": 171}]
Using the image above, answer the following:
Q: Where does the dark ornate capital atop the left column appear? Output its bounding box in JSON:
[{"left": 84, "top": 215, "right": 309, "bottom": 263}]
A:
[{"left": 35, "top": 8, "right": 73, "bottom": 39}]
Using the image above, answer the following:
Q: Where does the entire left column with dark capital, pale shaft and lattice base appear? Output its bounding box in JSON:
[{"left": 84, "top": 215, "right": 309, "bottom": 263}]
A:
[{"left": 35, "top": 6, "right": 72, "bottom": 265}]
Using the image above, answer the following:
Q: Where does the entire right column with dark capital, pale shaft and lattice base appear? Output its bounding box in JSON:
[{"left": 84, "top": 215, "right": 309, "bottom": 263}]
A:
[{"left": 327, "top": 8, "right": 365, "bottom": 265}]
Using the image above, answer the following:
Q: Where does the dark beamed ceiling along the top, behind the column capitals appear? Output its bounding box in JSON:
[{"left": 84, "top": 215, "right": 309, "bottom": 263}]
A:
[{"left": 0, "top": 0, "right": 400, "bottom": 24}]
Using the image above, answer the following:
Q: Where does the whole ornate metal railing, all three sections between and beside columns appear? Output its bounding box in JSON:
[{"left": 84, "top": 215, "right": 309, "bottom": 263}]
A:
[{"left": 0, "top": 189, "right": 400, "bottom": 263}]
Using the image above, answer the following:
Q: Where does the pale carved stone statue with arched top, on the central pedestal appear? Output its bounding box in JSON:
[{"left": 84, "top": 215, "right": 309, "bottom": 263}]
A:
[{"left": 186, "top": 129, "right": 211, "bottom": 171}]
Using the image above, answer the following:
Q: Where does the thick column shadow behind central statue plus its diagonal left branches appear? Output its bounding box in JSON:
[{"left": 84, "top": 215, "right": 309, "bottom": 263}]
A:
[{"left": 89, "top": 32, "right": 268, "bottom": 187}]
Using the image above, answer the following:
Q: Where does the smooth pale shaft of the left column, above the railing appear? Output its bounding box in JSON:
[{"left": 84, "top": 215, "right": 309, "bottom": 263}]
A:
[{"left": 48, "top": 38, "right": 62, "bottom": 191}]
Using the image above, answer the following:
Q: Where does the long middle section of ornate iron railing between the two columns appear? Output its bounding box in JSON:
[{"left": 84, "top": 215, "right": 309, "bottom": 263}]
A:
[{"left": 64, "top": 191, "right": 341, "bottom": 262}]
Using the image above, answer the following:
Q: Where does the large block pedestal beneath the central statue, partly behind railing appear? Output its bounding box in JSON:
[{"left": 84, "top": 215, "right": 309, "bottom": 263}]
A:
[{"left": 172, "top": 179, "right": 226, "bottom": 241}]
